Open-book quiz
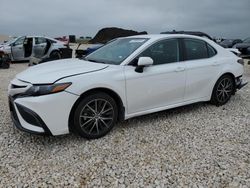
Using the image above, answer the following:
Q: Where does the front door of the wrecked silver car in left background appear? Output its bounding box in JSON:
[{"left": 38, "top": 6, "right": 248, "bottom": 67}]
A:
[{"left": 11, "top": 37, "right": 25, "bottom": 60}]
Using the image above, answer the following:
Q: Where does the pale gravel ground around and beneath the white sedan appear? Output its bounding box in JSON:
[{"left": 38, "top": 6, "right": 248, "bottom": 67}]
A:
[{"left": 0, "top": 61, "right": 250, "bottom": 187}]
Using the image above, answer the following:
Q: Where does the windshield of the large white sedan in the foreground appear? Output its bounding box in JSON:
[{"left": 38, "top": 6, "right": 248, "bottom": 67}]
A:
[{"left": 85, "top": 38, "right": 148, "bottom": 65}]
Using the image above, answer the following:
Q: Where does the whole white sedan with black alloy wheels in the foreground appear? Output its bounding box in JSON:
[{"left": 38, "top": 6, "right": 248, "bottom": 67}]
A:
[{"left": 8, "top": 34, "right": 246, "bottom": 139}]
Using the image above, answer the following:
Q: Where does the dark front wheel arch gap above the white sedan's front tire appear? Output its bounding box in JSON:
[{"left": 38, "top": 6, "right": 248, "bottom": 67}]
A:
[{"left": 68, "top": 87, "right": 125, "bottom": 132}]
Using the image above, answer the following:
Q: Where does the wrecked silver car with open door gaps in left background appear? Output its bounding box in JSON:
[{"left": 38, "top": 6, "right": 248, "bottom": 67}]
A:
[{"left": 0, "top": 36, "right": 66, "bottom": 61}]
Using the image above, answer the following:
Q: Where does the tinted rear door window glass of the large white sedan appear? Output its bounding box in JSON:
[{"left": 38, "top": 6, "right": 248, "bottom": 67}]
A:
[{"left": 184, "top": 39, "right": 208, "bottom": 60}]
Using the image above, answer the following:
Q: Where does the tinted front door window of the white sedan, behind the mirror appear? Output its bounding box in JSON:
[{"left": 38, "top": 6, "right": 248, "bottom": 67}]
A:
[{"left": 140, "top": 39, "right": 179, "bottom": 65}]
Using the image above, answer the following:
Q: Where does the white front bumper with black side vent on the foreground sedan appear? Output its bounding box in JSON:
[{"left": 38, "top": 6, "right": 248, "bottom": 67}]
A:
[{"left": 9, "top": 92, "right": 78, "bottom": 135}]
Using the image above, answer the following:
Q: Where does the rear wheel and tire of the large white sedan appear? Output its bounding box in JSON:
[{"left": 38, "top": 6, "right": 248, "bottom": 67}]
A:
[{"left": 210, "top": 74, "right": 235, "bottom": 106}]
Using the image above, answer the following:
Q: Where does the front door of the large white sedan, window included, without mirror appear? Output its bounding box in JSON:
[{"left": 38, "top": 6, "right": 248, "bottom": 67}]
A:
[{"left": 125, "top": 39, "right": 186, "bottom": 114}]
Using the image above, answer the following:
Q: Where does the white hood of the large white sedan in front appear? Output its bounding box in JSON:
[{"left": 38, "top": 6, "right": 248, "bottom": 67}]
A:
[{"left": 16, "top": 59, "right": 108, "bottom": 84}]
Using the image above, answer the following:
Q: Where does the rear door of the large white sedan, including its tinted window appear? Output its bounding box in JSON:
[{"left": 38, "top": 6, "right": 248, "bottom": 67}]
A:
[{"left": 182, "top": 38, "right": 219, "bottom": 101}]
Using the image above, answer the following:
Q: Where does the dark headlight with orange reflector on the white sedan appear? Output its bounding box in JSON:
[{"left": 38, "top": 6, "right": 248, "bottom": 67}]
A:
[{"left": 26, "top": 83, "right": 71, "bottom": 96}]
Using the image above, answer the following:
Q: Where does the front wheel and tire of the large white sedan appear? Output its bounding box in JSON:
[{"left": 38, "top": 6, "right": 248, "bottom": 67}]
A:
[{"left": 74, "top": 92, "right": 118, "bottom": 139}]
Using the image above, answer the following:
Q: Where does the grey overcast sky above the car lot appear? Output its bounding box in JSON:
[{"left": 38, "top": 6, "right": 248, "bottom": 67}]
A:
[{"left": 0, "top": 0, "right": 250, "bottom": 38}]
